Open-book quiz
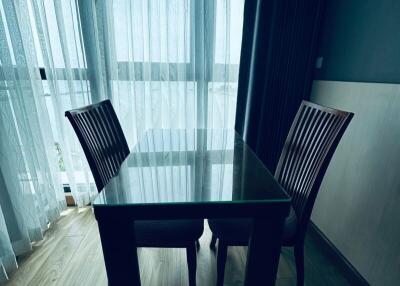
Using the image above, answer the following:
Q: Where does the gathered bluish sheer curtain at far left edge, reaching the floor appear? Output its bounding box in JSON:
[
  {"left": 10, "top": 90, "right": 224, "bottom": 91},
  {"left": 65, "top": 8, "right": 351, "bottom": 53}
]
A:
[{"left": 0, "top": 1, "right": 66, "bottom": 280}]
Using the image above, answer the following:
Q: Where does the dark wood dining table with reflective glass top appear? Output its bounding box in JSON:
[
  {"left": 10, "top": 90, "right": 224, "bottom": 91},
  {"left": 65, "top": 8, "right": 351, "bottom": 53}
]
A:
[{"left": 93, "top": 129, "right": 290, "bottom": 285}]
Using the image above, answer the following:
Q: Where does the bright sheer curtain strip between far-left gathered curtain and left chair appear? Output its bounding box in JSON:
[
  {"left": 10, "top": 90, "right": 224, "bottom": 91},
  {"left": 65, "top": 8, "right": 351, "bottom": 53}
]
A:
[{"left": 33, "top": 0, "right": 97, "bottom": 206}]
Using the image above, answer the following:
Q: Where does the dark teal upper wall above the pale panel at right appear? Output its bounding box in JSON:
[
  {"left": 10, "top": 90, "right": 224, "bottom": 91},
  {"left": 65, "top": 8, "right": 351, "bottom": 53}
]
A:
[{"left": 316, "top": 0, "right": 400, "bottom": 83}]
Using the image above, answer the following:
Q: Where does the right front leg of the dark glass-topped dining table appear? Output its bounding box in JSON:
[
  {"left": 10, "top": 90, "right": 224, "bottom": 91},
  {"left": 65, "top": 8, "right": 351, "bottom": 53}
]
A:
[{"left": 244, "top": 217, "right": 284, "bottom": 286}]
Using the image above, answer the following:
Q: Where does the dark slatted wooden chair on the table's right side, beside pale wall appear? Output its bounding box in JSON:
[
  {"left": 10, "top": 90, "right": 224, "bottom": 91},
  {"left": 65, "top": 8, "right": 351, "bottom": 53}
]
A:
[{"left": 208, "top": 101, "right": 353, "bottom": 286}]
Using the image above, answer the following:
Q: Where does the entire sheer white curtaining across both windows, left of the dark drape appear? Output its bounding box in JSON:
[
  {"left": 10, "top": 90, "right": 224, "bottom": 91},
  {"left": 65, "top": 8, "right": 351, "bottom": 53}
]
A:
[{"left": 0, "top": 0, "right": 244, "bottom": 282}]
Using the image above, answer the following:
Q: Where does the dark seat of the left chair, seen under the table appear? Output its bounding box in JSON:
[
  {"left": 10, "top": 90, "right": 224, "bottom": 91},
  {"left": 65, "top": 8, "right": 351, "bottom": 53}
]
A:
[{"left": 135, "top": 219, "right": 204, "bottom": 247}]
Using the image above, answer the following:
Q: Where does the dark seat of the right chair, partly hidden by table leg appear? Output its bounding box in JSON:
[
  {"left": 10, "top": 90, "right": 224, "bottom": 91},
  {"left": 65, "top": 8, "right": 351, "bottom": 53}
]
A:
[{"left": 208, "top": 207, "right": 297, "bottom": 245}]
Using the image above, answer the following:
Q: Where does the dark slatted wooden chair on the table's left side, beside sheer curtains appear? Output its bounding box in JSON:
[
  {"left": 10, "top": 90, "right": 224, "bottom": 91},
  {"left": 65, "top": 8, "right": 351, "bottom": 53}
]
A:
[{"left": 65, "top": 100, "right": 204, "bottom": 286}]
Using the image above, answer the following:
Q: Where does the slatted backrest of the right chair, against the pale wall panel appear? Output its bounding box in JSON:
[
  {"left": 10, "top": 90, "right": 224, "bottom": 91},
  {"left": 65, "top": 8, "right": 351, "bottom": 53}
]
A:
[{"left": 275, "top": 101, "right": 354, "bottom": 238}]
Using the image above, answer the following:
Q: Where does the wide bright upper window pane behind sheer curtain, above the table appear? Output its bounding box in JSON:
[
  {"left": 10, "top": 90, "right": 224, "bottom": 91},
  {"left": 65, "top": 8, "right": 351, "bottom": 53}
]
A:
[{"left": 113, "top": 0, "right": 191, "bottom": 63}]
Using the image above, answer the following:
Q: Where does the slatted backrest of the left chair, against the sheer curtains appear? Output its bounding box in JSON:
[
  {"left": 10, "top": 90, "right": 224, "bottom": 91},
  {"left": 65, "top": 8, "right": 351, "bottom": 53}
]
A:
[{"left": 65, "top": 100, "right": 129, "bottom": 192}]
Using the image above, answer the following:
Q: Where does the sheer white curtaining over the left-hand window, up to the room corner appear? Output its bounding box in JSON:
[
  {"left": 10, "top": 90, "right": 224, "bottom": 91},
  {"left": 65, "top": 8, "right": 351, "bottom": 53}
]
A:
[{"left": 0, "top": 0, "right": 96, "bottom": 282}]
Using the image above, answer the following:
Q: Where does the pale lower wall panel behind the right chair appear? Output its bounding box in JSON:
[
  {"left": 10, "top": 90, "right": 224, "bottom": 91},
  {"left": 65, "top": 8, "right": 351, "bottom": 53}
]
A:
[{"left": 311, "top": 81, "right": 400, "bottom": 285}]
